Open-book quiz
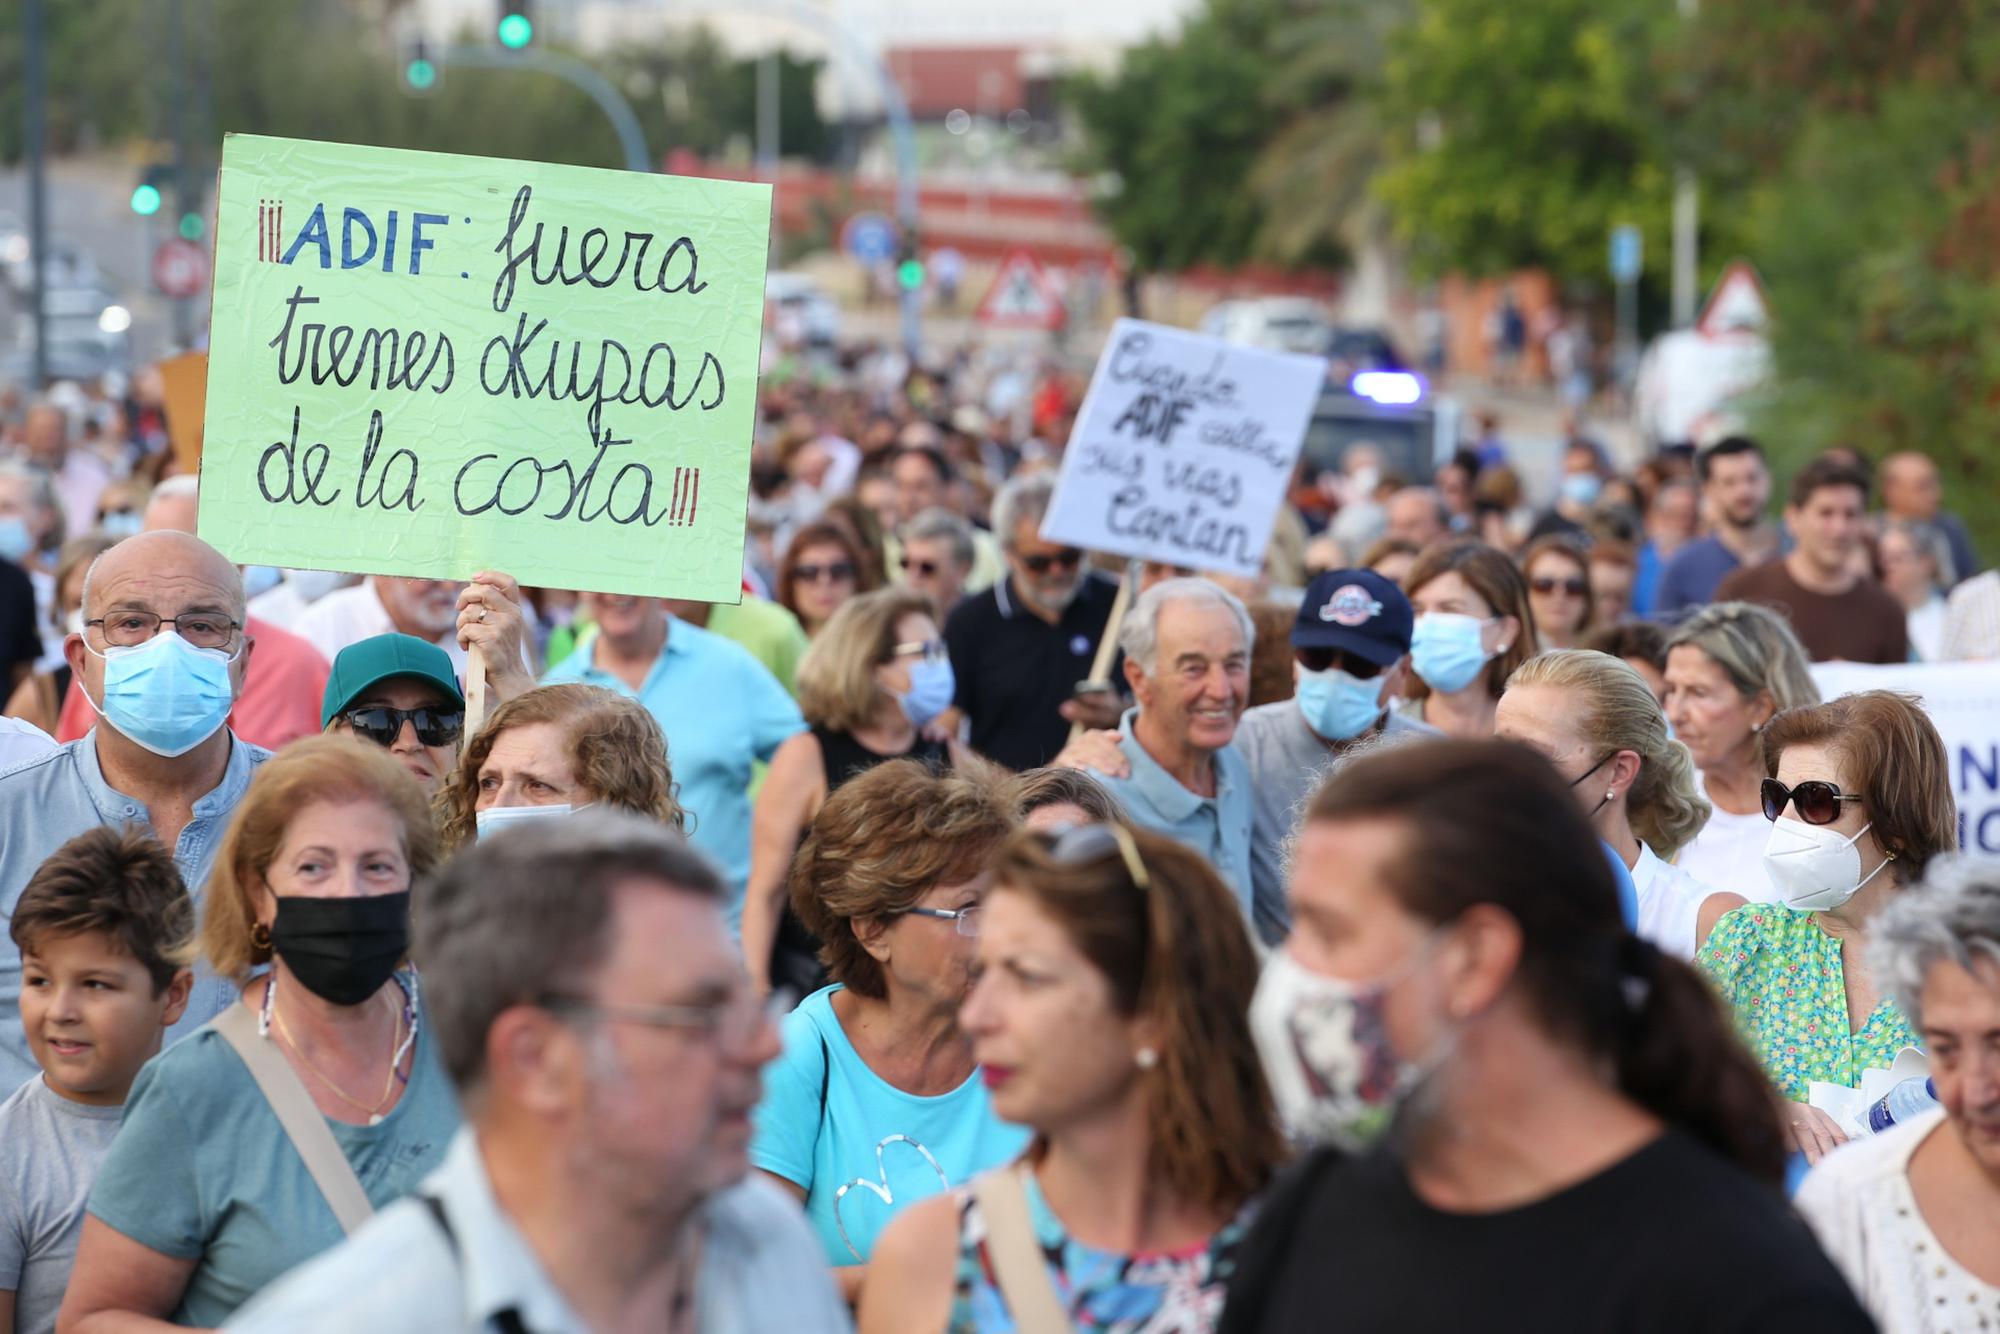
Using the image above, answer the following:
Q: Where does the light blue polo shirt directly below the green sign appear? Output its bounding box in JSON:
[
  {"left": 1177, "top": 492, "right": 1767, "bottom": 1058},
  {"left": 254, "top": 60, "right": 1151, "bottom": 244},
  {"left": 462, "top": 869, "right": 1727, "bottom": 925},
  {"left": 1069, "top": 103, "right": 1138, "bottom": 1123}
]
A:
[{"left": 542, "top": 616, "right": 806, "bottom": 930}]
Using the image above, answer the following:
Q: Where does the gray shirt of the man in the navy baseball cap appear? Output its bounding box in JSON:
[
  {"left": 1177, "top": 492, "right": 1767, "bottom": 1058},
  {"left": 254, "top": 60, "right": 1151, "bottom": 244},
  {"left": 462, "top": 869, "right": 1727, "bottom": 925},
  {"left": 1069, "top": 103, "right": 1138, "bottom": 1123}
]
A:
[{"left": 1236, "top": 700, "right": 1438, "bottom": 944}]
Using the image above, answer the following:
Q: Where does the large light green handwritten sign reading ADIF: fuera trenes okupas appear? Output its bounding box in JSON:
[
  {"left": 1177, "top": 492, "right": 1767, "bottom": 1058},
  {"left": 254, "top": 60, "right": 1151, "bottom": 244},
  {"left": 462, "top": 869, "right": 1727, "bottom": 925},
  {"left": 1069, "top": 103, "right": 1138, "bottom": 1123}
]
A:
[{"left": 200, "top": 134, "right": 770, "bottom": 602}]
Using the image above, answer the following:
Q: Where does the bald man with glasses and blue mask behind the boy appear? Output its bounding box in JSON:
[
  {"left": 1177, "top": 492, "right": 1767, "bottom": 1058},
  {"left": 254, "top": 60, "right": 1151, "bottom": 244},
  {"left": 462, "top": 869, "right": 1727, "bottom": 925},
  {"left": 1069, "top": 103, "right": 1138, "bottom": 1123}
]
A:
[{"left": 0, "top": 532, "right": 270, "bottom": 1094}]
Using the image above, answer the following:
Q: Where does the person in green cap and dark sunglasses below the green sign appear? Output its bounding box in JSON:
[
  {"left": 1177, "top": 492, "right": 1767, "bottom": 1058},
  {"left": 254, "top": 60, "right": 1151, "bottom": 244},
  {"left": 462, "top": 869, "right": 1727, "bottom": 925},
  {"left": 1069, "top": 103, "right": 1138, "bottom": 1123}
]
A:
[{"left": 320, "top": 634, "right": 466, "bottom": 800}]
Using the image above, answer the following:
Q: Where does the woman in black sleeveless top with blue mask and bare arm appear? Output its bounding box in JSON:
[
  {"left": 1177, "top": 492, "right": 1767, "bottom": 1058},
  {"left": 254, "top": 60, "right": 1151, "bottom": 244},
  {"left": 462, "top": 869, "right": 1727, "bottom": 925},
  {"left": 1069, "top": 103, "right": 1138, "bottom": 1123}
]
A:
[{"left": 742, "top": 588, "right": 954, "bottom": 996}]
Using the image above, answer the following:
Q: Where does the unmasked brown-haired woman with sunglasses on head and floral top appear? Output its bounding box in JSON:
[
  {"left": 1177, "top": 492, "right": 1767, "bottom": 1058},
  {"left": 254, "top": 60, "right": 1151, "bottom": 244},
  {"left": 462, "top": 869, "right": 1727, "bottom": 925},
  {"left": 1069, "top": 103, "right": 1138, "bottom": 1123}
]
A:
[{"left": 860, "top": 824, "right": 1286, "bottom": 1334}]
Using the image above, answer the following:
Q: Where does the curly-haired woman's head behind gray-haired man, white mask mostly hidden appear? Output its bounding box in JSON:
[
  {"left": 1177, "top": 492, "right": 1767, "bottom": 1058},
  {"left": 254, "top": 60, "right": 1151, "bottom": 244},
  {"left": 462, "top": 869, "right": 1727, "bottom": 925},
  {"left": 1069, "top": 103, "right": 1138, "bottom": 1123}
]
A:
[{"left": 434, "top": 682, "right": 686, "bottom": 852}]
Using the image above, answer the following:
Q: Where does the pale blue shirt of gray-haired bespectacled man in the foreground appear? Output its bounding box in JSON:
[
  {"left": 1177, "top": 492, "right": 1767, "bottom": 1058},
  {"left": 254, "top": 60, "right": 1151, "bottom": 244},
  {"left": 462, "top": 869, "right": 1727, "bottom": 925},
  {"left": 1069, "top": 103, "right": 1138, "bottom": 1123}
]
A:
[{"left": 224, "top": 1128, "right": 850, "bottom": 1334}]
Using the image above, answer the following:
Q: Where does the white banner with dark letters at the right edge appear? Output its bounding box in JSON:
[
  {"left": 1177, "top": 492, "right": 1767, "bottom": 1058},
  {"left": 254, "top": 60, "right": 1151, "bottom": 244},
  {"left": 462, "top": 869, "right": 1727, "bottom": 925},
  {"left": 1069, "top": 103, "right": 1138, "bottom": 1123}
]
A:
[{"left": 1812, "top": 662, "right": 2000, "bottom": 852}]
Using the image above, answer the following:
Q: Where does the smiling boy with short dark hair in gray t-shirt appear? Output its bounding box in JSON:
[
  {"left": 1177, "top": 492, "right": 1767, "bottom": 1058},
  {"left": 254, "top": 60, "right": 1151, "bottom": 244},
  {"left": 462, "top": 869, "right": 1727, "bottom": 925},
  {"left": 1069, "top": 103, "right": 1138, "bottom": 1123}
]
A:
[{"left": 0, "top": 826, "right": 194, "bottom": 1334}]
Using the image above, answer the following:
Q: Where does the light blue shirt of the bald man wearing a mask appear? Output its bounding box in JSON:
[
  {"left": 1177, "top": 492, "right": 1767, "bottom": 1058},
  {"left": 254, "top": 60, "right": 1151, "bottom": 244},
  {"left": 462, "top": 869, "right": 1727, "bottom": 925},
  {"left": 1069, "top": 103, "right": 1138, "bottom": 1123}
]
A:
[{"left": 0, "top": 728, "right": 270, "bottom": 1098}]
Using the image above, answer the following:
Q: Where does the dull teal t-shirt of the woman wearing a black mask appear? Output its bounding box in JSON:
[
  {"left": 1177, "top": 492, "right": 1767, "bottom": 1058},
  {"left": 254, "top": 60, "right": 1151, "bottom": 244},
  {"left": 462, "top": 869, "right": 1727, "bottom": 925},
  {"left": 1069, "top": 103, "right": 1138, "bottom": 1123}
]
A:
[{"left": 88, "top": 992, "right": 460, "bottom": 1328}]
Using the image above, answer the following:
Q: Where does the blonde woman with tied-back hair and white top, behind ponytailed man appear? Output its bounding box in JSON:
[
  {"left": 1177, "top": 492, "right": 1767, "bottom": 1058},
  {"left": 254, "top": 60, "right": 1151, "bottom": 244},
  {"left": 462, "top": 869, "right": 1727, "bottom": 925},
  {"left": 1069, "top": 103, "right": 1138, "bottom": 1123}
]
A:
[{"left": 1496, "top": 648, "right": 1744, "bottom": 960}]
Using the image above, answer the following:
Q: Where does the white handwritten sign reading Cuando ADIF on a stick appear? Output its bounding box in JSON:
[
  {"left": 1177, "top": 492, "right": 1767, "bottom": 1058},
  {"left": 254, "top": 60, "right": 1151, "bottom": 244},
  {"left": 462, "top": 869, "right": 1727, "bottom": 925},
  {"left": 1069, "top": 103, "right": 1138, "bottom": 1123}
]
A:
[{"left": 1032, "top": 320, "right": 1326, "bottom": 574}]
